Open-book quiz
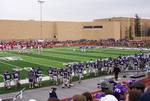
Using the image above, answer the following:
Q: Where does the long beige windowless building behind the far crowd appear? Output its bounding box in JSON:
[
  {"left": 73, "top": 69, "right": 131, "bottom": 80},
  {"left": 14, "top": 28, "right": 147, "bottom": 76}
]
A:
[{"left": 0, "top": 17, "right": 150, "bottom": 41}]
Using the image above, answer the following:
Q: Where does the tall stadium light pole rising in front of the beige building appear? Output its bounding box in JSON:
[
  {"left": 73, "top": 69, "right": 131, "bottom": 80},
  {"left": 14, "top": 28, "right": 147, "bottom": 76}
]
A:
[{"left": 38, "top": 0, "right": 45, "bottom": 39}]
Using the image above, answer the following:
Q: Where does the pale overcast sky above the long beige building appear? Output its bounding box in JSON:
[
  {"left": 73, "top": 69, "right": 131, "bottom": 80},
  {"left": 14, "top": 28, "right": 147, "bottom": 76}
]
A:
[{"left": 0, "top": 0, "right": 150, "bottom": 21}]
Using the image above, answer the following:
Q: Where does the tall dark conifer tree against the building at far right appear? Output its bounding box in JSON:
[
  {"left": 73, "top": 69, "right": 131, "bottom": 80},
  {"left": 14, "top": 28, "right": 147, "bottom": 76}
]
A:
[{"left": 134, "top": 14, "right": 142, "bottom": 37}]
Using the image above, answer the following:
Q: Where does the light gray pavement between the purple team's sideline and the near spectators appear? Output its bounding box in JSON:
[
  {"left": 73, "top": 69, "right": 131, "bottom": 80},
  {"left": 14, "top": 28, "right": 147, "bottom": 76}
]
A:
[{"left": 0, "top": 73, "right": 145, "bottom": 101}]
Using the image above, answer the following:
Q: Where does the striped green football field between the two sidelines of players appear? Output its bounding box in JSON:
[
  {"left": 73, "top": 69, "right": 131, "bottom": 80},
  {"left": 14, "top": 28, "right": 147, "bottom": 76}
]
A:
[{"left": 0, "top": 47, "right": 143, "bottom": 82}]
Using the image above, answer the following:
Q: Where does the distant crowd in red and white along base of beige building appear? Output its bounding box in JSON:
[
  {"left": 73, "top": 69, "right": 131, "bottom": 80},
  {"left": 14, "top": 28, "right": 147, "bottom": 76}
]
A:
[{"left": 0, "top": 39, "right": 150, "bottom": 51}]
